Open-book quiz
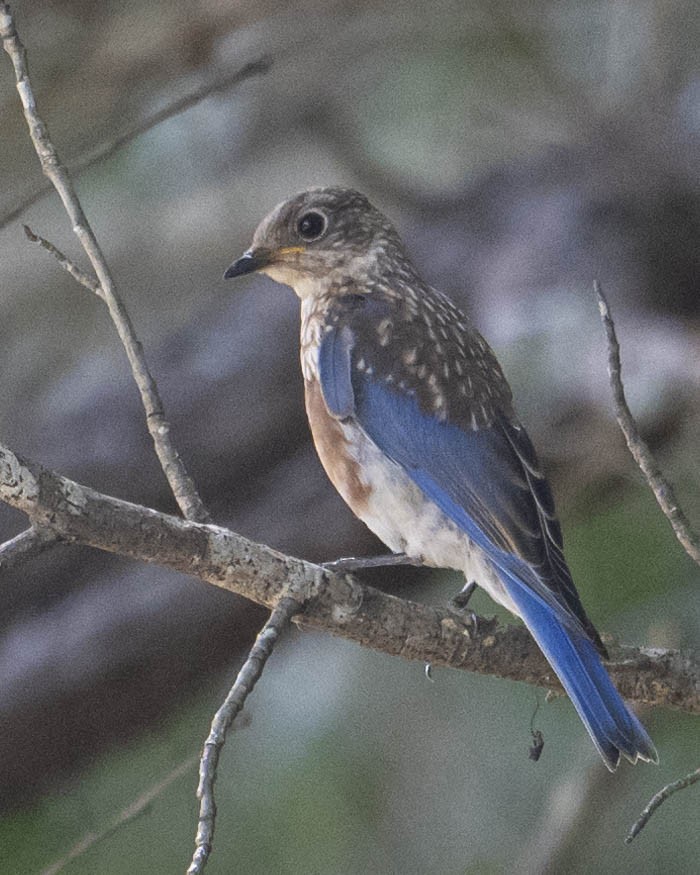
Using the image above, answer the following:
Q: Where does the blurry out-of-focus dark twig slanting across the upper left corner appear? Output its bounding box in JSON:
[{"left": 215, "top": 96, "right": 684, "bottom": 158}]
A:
[{"left": 0, "top": 57, "right": 272, "bottom": 231}]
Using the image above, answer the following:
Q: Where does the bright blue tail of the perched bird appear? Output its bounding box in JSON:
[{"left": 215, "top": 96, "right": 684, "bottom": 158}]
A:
[{"left": 508, "top": 574, "right": 659, "bottom": 772}]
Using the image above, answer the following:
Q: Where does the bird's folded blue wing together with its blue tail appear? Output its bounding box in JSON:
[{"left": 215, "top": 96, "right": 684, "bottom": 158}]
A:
[{"left": 319, "top": 327, "right": 657, "bottom": 770}]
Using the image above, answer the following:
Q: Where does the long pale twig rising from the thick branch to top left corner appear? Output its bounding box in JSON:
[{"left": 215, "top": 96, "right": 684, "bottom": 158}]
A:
[{"left": 0, "top": 3, "right": 209, "bottom": 522}]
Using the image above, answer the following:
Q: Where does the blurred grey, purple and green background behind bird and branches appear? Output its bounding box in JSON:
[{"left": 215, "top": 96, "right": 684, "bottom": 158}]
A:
[{"left": 0, "top": 0, "right": 700, "bottom": 875}]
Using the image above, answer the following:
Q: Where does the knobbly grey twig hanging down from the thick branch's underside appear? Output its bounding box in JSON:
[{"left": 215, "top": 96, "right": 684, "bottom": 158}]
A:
[{"left": 187, "top": 596, "right": 303, "bottom": 875}]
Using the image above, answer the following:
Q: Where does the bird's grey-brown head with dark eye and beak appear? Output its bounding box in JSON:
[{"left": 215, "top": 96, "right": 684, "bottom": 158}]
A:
[{"left": 224, "top": 188, "right": 406, "bottom": 299}]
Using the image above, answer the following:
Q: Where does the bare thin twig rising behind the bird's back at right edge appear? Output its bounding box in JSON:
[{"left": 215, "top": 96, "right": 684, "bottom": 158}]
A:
[{"left": 593, "top": 280, "right": 700, "bottom": 565}]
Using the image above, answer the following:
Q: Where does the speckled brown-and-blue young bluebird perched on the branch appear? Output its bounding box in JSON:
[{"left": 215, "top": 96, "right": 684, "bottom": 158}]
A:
[{"left": 224, "top": 187, "right": 658, "bottom": 771}]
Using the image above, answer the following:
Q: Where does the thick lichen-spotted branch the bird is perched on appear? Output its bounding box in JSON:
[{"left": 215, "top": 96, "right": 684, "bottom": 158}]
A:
[{"left": 0, "top": 445, "right": 700, "bottom": 713}]
